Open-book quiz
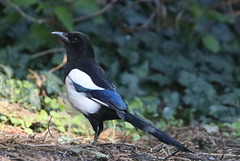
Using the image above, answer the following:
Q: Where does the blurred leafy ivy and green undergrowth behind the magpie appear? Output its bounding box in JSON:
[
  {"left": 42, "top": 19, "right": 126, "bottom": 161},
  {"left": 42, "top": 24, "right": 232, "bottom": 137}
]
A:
[{"left": 0, "top": 0, "right": 240, "bottom": 138}]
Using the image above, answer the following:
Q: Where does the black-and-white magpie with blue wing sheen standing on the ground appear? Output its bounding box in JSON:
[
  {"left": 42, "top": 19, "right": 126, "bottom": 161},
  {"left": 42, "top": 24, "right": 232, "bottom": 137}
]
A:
[{"left": 51, "top": 31, "right": 192, "bottom": 152}]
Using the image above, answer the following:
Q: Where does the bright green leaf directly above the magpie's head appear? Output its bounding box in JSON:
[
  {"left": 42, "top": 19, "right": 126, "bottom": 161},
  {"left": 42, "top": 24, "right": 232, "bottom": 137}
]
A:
[{"left": 54, "top": 6, "right": 73, "bottom": 31}]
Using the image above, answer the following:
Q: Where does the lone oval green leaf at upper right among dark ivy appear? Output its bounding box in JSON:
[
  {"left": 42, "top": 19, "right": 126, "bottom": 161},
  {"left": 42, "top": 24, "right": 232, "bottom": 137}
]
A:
[{"left": 202, "top": 34, "right": 220, "bottom": 53}]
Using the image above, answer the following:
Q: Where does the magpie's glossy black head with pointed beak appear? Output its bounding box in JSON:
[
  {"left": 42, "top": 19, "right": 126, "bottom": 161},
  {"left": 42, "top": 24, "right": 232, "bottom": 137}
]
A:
[{"left": 52, "top": 31, "right": 94, "bottom": 60}]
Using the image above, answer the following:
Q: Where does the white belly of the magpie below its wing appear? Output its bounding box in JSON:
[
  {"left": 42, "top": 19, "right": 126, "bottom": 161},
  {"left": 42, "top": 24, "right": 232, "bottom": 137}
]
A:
[{"left": 65, "top": 77, "right": 101, "bottom": 115}]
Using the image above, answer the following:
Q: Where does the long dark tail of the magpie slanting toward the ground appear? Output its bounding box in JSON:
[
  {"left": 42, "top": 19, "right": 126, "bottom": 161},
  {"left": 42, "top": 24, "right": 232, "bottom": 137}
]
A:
[{"left": 117, "top": 111, "right": 193, "bottom": 153}]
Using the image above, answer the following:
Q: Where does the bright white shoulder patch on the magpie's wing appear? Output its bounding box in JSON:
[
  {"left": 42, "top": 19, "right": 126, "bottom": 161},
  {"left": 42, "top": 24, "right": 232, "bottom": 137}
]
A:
[{"left": 68, "top": 69, "right": 104, "bottom": 90}]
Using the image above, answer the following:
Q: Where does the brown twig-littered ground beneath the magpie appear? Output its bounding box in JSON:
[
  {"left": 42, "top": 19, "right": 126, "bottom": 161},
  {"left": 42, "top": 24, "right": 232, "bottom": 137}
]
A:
[{"left": 0, "top": 126, "right": 240, "bottom": 161}]
